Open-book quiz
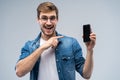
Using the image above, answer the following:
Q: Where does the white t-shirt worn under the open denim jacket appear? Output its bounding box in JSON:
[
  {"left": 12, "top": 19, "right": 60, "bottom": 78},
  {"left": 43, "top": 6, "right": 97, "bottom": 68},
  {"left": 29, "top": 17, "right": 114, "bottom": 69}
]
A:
[{"left": 38, "top": 38, "right": 59, "bottom": 80}]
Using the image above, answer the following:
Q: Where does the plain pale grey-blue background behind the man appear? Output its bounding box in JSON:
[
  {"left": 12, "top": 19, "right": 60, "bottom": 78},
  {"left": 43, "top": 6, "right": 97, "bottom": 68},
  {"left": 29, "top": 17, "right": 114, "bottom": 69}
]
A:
[{"left": 0, "top": 0, "right": 120, "bottom": 80}]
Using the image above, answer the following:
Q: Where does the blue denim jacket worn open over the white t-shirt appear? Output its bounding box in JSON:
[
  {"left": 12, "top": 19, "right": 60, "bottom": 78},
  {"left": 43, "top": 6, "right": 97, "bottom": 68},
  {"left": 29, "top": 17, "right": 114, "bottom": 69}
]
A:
[{"left": 19, "top": 33, "right": 85, "bottom": 80}]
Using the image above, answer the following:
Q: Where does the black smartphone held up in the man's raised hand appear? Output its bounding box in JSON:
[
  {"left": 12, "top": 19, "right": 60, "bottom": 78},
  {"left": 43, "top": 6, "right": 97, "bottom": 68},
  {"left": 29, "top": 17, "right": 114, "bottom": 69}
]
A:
[{"left": 83, "top": 24, "right": 91, "bottom": 42}]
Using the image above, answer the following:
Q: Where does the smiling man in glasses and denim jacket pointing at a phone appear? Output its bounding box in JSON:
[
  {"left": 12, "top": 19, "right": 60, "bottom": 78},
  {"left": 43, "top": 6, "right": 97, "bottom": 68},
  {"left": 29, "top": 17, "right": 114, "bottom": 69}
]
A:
[{"left": 16, "top": 2, "right": 96, "bottom": 80}]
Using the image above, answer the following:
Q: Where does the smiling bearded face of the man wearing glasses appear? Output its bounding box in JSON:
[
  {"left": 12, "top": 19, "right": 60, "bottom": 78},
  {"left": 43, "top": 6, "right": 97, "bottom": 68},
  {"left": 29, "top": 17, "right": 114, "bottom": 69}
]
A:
[{"left": 38, "top": 11, "right": 58, "bottom": 37}]
